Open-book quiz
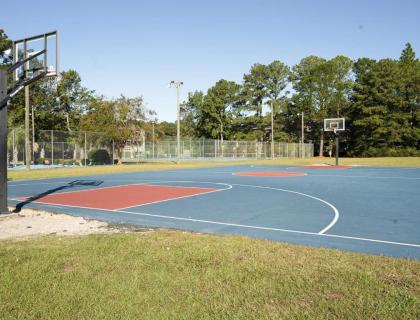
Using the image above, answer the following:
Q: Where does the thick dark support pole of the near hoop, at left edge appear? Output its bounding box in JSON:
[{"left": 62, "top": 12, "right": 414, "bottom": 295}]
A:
[{"left": 0, "top": 70, "right": 9, "bottom": 214}]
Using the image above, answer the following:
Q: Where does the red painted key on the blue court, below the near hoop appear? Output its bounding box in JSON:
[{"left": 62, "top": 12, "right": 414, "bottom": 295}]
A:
[{"left": 22, "top": 185, "right": 217, "bottom": 210}]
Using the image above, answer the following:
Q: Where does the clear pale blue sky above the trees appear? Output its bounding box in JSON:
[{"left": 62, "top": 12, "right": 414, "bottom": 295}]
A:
[{"left": 0, "top": 0, "right": 420, "bottom": 121}]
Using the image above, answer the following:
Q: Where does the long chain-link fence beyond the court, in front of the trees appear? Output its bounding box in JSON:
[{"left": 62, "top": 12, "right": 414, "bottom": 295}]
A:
[{"left": 8, "top": 129, "right": 314, "bottom": 165}]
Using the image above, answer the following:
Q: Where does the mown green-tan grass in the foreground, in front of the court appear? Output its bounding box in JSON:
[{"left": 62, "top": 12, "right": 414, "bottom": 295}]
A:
[{"left": 0, "top": 230, "right": 420, "bottom": 319}]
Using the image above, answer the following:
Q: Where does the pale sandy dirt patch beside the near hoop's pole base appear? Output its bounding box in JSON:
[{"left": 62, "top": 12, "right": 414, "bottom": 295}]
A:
[{"left": 0, "top": 209, "right": 120, "bottom": 240}]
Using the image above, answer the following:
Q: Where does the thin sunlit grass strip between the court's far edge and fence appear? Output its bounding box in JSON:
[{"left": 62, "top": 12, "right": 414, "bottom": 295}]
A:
[{"left": 8, "top": 157, "right": 420, "bottom": 180}]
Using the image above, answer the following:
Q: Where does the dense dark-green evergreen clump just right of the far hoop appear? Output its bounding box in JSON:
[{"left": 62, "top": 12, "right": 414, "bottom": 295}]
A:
[{"left": 350, "top": 44, "right": 420, "bottom": 156}]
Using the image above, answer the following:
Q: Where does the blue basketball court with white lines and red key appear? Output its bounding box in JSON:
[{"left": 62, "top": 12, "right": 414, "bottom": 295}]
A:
[{"left": 9, "top": 165, "right": 420, "bottom": 259}]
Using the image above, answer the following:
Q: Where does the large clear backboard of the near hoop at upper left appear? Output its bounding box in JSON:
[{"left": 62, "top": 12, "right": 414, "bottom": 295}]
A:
[{"left": 13, "top": 31, "right": 59, "bottom": 82}]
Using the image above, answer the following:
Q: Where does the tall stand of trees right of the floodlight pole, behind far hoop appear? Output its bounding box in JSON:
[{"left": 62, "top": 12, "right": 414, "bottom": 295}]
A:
[{"left": 182, "top": 47, "right": 420, "bottom": 156}]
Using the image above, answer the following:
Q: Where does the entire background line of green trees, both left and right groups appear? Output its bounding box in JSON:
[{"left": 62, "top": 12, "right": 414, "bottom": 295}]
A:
[{"left": 0, "top": 29, "right": 420, "bottom": 156}]
